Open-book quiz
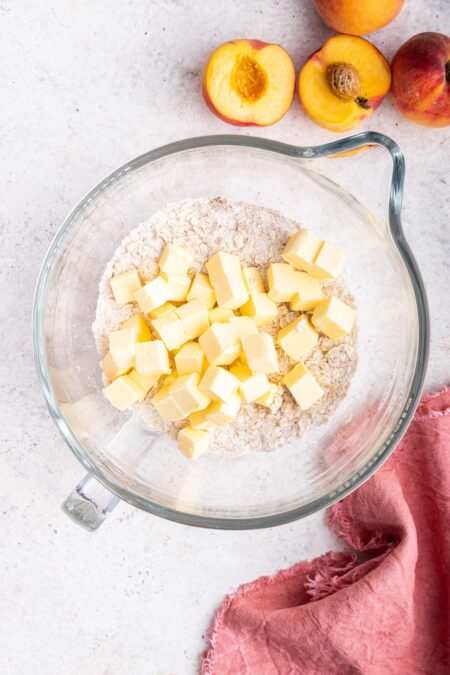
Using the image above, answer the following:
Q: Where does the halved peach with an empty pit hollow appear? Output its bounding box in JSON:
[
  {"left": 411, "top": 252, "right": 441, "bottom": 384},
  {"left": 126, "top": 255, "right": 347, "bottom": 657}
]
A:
[{"left": 203, "top": 40, "right": 295, "bottom": 126}]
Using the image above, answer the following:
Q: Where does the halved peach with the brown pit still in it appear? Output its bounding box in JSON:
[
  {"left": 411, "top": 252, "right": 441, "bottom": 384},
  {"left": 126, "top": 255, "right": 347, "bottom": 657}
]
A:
[{"left": 298, "top": 35, "right": 391, "bottom": 132}]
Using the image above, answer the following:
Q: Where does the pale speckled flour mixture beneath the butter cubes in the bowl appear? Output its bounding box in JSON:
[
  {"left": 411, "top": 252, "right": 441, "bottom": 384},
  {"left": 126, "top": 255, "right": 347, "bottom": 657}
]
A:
[{"left": 92, "top": 198, "right": 357, "bottom": 453}]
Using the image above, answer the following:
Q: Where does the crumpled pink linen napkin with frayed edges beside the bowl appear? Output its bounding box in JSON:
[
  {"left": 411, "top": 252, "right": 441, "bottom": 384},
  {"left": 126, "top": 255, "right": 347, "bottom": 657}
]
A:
[{"left": 202, "top": 388, "right": 450, "bottom": 675}]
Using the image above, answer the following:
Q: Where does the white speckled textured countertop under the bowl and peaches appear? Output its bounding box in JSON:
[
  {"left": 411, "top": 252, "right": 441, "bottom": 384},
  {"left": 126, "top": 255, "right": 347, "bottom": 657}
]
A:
[{"left": 0, "top": 0, "right": 450, "bottom": 675}]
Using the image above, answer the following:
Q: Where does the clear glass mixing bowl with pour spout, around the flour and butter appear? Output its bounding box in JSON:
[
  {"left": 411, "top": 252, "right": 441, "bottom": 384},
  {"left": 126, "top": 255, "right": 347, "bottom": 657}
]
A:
[{"left": 34, "top": 132, "right": 429, "bottom": 529}]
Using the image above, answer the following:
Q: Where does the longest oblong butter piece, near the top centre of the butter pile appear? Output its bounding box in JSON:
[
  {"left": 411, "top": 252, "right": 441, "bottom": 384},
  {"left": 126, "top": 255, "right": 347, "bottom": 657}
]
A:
[{"left": 206, "top": 252, "right": 248, "bottom": 309}]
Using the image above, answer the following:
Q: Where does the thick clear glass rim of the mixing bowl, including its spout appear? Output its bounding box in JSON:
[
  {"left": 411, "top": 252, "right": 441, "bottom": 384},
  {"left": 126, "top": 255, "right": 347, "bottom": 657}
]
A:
[{"left": 33, "top": 131, "right": 430, "bottom": 530}]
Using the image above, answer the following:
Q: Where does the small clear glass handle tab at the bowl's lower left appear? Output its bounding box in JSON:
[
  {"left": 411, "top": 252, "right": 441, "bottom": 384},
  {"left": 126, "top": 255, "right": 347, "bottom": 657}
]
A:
[{"left": 62, "top": 474, "right": 120, "bottom": 532}]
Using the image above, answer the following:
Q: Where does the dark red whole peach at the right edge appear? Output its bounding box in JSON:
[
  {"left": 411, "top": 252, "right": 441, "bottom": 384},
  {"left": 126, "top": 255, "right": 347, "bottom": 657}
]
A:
[{"left": 391, "top": 33, "right": 450, "bottom": 127}]
